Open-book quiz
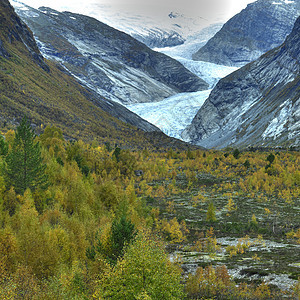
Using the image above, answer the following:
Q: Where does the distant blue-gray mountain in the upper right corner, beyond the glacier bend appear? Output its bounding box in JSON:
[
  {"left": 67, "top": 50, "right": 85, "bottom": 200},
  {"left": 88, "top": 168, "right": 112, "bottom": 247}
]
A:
[{"left": 193, "top": 0, "right": 300, "bottom": 67}]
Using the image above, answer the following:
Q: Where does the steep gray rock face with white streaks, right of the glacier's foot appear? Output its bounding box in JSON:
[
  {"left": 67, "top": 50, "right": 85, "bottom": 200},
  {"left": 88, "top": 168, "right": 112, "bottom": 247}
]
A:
[{"left": 183, "top": 17, "right": 300, "bottom": 148}]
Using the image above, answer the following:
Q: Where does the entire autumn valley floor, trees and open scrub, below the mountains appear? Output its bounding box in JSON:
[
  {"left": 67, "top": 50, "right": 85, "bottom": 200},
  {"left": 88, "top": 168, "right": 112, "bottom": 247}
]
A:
[{"left": 0, "top": 120, "right": 300, "bottom": 299}]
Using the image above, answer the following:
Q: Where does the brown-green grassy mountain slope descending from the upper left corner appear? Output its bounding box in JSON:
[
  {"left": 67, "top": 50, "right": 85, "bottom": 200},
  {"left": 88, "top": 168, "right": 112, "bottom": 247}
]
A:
[{"left": 0, "top": 0, "right": 166, "bottom": 146}]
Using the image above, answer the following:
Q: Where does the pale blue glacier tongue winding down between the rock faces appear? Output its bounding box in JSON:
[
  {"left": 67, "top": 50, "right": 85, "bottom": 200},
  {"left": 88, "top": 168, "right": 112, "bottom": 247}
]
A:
[{"left": 126, "top": 36, "right": 238, "bottom": 141}]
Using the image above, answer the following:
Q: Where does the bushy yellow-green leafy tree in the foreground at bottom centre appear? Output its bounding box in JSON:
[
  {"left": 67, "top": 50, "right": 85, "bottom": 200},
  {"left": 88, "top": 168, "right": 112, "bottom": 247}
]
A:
[{"left": 99, "top": 234, "right": 184, "bottom": 300}]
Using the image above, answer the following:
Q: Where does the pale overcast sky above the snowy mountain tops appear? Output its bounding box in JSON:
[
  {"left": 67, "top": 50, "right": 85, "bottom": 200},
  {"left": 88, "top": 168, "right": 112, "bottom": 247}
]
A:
[{"left": 15, "top": 0, "right": 255, "bottom": 19}]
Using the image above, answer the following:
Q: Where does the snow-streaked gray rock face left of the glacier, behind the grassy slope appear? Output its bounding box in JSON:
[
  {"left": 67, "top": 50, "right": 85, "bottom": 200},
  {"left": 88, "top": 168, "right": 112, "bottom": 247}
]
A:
[{"left": 16, "top": 7, "right": 208, "bottom": 103}]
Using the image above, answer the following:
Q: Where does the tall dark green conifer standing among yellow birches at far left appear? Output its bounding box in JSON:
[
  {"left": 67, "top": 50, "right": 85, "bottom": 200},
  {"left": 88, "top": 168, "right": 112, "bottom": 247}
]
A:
[{"left": 5, "top": 117, "right": 47, "bottom": 194}]
